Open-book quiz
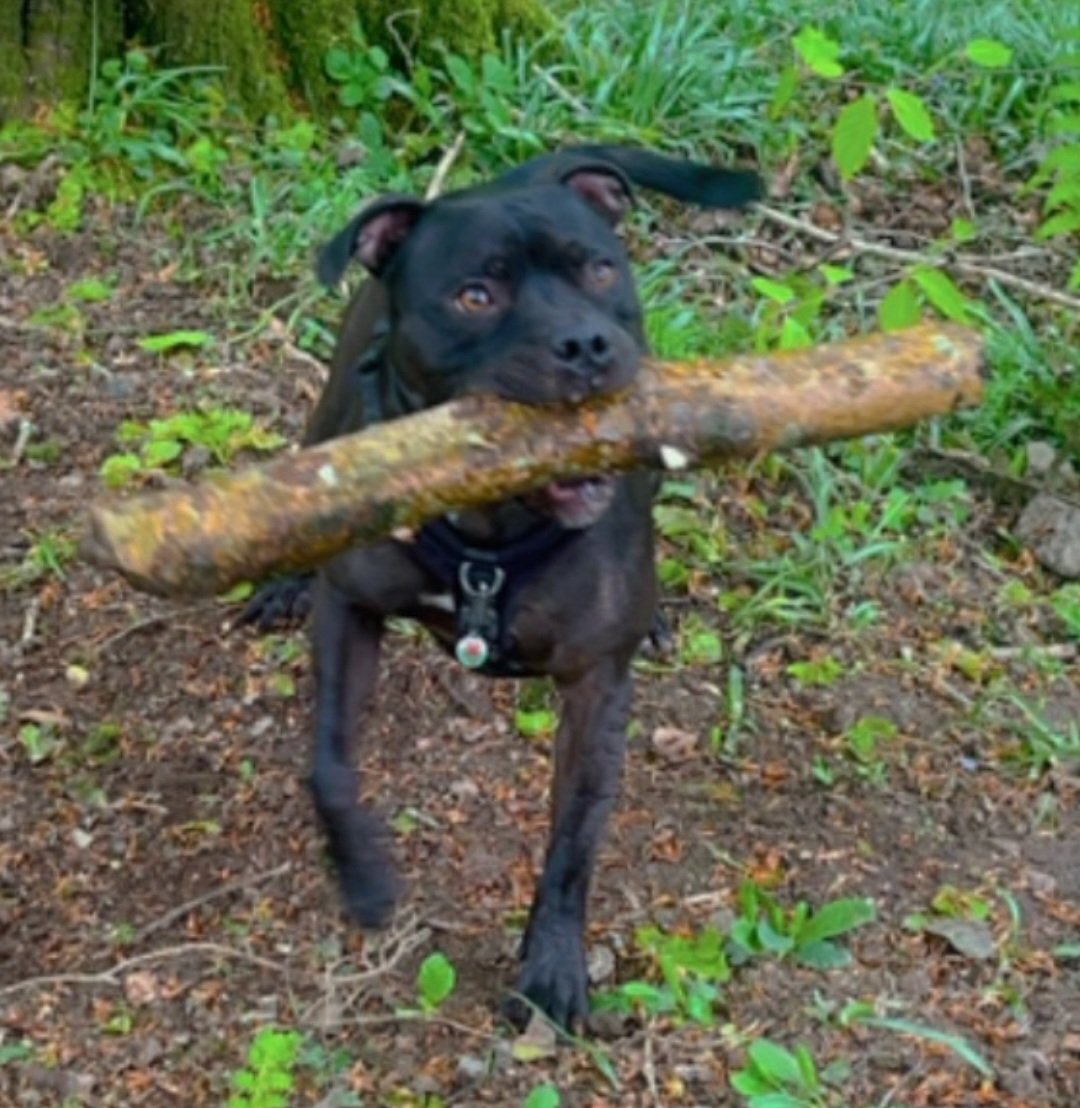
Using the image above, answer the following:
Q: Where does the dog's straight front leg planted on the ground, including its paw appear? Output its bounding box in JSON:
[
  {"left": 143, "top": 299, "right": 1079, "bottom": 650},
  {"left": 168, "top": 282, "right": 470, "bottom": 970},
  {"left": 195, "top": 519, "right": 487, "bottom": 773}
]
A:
[{"left": 506, "top": 658, "right": 630, "bottom": 1028}]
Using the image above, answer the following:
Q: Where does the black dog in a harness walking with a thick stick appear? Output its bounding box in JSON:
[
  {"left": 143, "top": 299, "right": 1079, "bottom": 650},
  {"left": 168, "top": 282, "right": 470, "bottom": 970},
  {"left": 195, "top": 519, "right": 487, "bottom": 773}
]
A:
[{"left": 248, "top": 146, "right": 760, "bottom": 1027}]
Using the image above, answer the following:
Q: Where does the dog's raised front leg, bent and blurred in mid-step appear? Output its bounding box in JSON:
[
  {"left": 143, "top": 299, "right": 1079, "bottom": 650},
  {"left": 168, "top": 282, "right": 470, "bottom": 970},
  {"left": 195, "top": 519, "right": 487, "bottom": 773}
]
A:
[{"left": 311, "top": 575, "right": 398, "bottom": 927}]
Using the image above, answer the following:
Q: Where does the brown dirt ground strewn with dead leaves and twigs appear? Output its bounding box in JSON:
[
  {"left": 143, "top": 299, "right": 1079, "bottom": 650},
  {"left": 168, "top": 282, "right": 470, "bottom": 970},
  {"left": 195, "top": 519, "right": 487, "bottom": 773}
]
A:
[{"left": 0, "top": 201, "right": 1080, "bottom": 1108}]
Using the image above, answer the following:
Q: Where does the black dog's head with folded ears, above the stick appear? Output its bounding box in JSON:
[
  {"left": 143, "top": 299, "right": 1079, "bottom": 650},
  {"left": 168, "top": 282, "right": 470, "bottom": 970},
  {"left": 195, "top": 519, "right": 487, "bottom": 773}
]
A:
[{"left": 318, "top": 162, "right": 644, "bottom": 407}]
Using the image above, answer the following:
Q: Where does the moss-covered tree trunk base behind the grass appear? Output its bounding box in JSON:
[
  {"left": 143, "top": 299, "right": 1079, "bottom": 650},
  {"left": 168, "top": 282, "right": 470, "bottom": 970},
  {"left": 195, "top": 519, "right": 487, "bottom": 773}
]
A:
[{"left": 0, "top": 0, "right": 545, "bottom": 122}]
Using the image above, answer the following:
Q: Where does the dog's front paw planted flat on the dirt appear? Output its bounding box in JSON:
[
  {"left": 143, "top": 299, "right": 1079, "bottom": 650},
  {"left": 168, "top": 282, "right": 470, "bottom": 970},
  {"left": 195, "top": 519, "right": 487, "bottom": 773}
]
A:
[{"left": 503, "top": 917, "right": 589, "bottom": 1032}]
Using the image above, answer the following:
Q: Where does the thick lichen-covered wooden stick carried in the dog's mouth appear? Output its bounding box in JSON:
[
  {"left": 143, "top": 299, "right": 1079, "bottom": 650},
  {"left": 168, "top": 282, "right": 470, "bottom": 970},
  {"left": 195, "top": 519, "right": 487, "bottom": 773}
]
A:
[{"left": 82, "top": 324, "right": 983, "bottom": 596}]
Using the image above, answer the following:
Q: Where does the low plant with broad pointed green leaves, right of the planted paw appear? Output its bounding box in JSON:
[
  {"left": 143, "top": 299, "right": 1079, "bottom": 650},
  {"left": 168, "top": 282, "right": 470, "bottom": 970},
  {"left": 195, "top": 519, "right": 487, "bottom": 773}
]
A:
[{"left": 729, "top": 881, "right": 877, "bottom": 970}]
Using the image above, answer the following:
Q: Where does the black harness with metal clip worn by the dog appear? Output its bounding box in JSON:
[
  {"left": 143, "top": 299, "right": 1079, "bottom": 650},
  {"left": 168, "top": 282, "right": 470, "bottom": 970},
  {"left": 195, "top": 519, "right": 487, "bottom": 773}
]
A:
[{"left": 356, "top": 322, "right": 584, "bottom": 677}]
